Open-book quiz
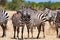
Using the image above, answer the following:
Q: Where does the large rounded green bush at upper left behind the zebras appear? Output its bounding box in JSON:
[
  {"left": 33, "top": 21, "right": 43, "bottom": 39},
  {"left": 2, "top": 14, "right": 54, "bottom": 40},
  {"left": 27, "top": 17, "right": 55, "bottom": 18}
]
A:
[{"left": 5, "top": 0, "right": 24, "bottom": 10}]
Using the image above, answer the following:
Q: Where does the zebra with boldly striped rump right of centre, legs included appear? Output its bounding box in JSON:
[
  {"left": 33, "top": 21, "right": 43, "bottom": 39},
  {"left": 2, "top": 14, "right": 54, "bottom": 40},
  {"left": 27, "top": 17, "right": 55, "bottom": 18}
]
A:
[{"left": 30, "top": 10, "right": 45, "bottom": 38}]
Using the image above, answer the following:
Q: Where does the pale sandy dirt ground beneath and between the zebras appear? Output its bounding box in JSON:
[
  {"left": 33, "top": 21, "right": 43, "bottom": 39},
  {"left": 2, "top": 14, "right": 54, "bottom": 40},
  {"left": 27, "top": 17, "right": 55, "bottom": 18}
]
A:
[{"left": 0, "top": 11, "right": 60, "bottom": 40}]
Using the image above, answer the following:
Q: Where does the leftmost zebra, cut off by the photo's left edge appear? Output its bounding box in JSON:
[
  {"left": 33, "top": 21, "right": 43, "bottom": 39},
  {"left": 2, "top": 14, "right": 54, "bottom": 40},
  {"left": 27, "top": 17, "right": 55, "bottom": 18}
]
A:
[{"left": 0, "top": 9, "right": 9, "bottom": 37}]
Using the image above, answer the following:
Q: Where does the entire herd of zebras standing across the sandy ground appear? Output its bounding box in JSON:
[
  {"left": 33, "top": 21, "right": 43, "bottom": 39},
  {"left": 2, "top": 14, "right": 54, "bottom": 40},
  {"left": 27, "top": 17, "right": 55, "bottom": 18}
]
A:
[{"left": 0, "top": 7, "right": 60, "bottom": 38}]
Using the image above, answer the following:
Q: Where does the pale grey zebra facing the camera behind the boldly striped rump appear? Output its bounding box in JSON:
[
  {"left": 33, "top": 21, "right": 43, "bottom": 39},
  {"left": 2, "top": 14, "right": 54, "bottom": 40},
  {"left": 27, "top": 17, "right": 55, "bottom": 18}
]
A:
[{"left": 44, "top": 8, "right": 57, "bottom": 28}]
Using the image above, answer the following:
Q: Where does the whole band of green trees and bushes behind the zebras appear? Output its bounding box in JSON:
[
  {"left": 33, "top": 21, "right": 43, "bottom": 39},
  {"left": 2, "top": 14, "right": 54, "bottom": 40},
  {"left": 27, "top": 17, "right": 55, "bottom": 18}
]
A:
[{"left": 0, "top": 0, "right": 60, "bottom": 10}]
